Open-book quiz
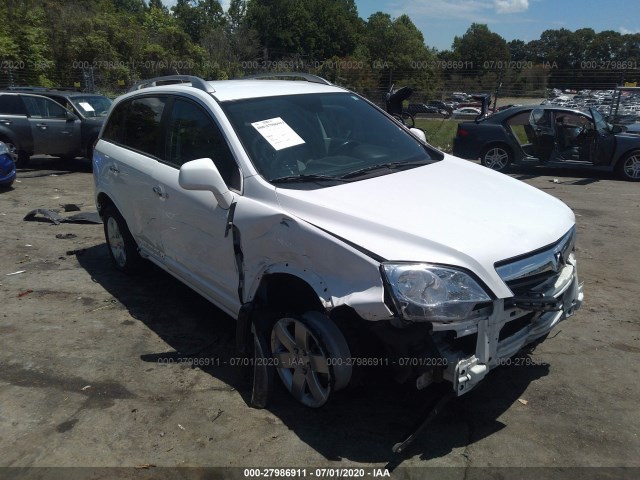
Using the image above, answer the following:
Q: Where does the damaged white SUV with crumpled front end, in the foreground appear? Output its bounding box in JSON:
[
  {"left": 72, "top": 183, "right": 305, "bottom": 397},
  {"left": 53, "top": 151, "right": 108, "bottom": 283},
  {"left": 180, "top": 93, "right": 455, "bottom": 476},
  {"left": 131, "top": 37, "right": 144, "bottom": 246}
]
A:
[{"left": 93, "top": 74, "right": 583, "bottom": 407}]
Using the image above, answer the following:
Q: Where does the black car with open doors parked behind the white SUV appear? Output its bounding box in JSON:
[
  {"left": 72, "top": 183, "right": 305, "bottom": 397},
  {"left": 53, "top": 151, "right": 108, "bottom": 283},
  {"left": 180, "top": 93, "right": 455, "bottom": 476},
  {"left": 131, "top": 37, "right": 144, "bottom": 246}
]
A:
[{"left": 453, "top": 105, "right": 640, "bottom": 181}]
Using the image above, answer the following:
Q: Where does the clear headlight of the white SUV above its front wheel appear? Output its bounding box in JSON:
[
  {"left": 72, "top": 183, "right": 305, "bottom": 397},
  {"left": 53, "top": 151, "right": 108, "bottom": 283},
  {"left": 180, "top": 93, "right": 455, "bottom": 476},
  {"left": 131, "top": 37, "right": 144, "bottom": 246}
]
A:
[{"left": 382, "top": 263, "right": 491, "bottom": 322}]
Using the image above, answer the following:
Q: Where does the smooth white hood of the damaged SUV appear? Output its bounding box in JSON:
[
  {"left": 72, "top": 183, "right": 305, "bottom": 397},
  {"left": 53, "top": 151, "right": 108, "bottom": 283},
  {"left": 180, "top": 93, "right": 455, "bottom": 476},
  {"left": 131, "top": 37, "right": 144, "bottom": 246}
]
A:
[{"left": 276, "top": 155, "right": 575, "bottom": 297}]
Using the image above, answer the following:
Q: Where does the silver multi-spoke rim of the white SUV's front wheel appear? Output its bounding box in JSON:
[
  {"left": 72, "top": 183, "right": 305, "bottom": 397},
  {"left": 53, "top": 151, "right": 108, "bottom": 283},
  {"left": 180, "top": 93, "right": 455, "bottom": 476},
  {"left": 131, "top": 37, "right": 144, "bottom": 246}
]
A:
[{"left": 271, "top": 318, "right": 331, "bottom": 407}]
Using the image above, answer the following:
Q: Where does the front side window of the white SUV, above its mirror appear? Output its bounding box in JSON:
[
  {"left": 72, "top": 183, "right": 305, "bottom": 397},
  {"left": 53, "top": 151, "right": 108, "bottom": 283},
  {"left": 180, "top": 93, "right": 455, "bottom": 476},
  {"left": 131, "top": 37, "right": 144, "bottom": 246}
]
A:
[{"left": 166, "top": 98, "right": 240, "bottom": 189}]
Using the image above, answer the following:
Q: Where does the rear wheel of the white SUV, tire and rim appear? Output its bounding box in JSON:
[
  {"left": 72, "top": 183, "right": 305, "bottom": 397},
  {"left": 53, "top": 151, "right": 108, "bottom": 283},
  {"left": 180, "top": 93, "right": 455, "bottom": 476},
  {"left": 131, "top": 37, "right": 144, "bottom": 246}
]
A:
[{"left": 102, "top": 206, "right": 142, "bottom": 273}]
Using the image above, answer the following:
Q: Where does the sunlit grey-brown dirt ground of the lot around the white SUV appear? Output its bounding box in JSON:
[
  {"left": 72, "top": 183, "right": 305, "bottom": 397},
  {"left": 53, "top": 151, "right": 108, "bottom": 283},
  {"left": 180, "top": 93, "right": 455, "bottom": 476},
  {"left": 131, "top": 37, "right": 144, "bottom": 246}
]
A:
[{"left": 0, "top": 157, "right": 640, "bottom": 479}]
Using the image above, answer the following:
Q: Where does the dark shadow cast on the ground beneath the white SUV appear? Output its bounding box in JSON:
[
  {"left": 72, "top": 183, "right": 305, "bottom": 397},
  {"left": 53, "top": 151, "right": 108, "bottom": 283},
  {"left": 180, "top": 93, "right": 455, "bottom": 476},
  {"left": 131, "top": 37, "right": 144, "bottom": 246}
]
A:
[{"left": 77, "top": 244, "right": 548, "bottom": 469}]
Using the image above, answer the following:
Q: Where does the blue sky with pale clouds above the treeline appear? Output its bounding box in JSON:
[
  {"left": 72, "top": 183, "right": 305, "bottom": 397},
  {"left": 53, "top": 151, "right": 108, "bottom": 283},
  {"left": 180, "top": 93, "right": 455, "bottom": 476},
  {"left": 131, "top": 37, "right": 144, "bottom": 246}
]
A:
[{"left": 163, "top": 0, "right": 640, "bottom": 50}]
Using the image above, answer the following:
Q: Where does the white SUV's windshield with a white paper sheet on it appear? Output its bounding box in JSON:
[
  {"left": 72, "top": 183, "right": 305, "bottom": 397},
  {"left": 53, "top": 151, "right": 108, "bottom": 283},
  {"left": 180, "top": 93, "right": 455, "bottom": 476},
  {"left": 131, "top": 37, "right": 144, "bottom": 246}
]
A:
[{"left": 223, "top": 92, "right": 442, "bottom": 182}]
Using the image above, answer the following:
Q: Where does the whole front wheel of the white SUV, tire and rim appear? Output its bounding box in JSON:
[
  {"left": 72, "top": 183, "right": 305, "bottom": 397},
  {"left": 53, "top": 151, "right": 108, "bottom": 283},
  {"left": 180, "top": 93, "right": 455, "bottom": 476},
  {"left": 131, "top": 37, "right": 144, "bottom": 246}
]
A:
[{"left": 271, "top": 311, "right": 352, "bottom": 408}]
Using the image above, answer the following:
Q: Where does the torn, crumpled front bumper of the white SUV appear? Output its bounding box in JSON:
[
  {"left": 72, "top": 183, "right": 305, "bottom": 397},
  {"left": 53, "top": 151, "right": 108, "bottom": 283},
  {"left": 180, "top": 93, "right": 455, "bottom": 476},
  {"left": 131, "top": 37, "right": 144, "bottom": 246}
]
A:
[{"left": 436, "top": 260, "right": 583, "bottom": 396}]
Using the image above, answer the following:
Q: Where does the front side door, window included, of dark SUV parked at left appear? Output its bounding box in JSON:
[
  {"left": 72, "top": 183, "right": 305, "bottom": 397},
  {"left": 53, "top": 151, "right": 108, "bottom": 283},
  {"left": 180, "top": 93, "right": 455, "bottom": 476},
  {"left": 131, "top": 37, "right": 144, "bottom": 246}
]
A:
[{"left": 22, "top": 95, "right": 81, "bottom": 155}]
